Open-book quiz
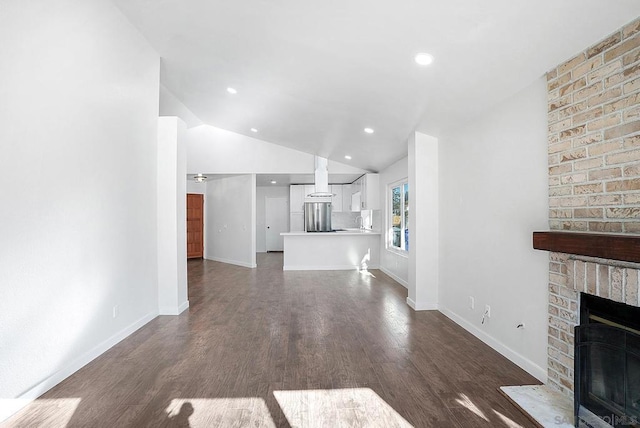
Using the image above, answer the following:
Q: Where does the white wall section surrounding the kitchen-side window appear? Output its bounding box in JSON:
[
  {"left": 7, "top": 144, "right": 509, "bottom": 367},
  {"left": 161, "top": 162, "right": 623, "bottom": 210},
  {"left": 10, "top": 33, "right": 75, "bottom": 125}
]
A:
[{"left": 380, "top": 157, "right": 411, "bottom": 287}]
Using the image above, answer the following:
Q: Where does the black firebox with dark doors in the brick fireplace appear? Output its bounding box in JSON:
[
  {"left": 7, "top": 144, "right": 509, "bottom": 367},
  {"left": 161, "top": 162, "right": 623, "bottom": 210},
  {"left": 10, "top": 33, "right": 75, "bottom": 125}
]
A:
[{"left": 574, "top": 293, "right": 640, "bottom": 428}]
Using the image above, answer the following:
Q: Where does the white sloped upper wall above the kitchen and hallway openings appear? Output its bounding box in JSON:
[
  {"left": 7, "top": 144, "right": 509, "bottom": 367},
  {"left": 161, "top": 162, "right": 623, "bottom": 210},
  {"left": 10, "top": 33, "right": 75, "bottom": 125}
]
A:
[{"left": 187, "top": 125, "right": 367, "bottom": 174}]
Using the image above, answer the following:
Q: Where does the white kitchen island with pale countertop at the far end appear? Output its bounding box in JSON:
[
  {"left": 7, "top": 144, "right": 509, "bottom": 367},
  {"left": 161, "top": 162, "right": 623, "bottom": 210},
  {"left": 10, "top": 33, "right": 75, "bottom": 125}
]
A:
[{"left": 281, "top": 229, "right": 380, "bottom": 270}]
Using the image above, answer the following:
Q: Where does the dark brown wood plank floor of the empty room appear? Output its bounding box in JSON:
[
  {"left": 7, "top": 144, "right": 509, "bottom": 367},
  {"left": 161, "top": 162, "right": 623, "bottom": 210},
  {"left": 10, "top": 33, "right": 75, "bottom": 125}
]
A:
[{"left": 3, "top": 253, "right": 538, "bottom": 427}]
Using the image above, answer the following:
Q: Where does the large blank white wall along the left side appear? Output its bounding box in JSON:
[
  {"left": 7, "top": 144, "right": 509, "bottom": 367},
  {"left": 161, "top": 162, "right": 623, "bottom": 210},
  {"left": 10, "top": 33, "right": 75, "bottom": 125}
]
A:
[{"left": 0, "top": 0, "right": 159, "bottom": 419}]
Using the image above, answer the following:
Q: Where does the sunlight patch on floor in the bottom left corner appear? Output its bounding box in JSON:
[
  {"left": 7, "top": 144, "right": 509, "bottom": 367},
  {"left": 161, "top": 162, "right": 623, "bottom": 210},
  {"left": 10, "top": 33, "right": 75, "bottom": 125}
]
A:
[{"left": 0, "top": 398, "right": 82, "bottom": 427}]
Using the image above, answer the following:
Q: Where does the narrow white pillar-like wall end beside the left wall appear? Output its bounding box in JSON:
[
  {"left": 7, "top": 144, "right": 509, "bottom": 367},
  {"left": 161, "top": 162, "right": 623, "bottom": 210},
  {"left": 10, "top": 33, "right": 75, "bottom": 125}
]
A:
[{"left": 158, "top": 117, "right": 189, "bottom": 315}]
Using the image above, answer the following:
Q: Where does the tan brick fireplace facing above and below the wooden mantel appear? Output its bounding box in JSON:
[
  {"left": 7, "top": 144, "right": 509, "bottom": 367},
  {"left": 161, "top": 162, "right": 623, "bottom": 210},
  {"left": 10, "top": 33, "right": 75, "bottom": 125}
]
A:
[{"left": 547, "top": 19, "right": 640, "bottom": 395}]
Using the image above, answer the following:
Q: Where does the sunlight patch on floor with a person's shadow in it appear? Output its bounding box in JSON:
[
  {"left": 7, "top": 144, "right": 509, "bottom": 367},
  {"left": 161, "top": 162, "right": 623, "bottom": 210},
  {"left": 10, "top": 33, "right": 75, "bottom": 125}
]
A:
[{"left": 165, "top": 397, "right": 276, "bottom": 428}]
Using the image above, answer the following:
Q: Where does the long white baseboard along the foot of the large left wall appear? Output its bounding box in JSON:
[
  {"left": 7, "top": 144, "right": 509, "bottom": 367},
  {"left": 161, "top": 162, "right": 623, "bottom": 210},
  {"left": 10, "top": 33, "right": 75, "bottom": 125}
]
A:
[{"left": 0, "top": 312, "right": 158, "bottom": 422}]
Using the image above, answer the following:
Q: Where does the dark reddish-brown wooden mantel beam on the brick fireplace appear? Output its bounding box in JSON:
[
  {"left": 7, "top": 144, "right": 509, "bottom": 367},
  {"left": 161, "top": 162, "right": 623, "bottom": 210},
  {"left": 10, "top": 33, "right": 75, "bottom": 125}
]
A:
[{"left": 533, "top": 231, "right": 640, "bottom": 263}]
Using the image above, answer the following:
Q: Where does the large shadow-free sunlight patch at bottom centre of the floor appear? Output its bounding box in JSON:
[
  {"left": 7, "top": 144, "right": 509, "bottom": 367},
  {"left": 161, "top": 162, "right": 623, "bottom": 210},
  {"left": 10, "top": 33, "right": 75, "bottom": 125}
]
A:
[{"left": 273, "top": 388, "right": 412, "bottom": 428}]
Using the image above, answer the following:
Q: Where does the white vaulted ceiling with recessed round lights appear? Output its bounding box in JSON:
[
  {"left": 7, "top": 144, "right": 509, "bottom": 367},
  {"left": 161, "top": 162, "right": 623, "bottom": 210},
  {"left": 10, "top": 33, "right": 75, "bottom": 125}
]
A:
[{"left": 114, "top": 0, "right": 640, "bottom": 171}]
